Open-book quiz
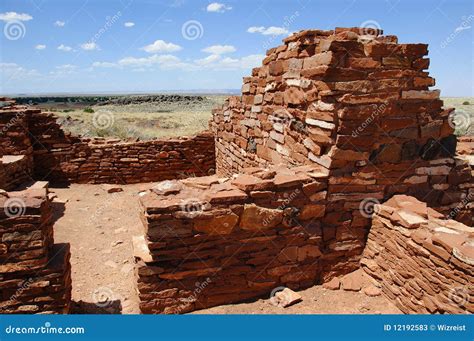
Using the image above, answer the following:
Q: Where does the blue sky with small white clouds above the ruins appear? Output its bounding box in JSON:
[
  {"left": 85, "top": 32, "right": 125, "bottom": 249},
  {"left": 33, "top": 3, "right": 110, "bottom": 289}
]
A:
[{"left": 0, "top": 0, "right": 474, "bottom": 96}]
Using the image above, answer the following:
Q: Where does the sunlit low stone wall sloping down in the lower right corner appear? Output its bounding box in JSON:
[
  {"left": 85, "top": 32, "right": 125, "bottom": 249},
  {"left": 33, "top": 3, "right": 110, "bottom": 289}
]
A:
[{"left": 361, "top": 195, "right": 474, "bottom": 314}]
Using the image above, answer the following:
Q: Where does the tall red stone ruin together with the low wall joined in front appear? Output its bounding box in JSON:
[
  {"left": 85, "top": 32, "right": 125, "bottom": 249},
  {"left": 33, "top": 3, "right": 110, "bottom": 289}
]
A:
[{"left": 136, "top": 28, "right": 474, "bottom": 313}]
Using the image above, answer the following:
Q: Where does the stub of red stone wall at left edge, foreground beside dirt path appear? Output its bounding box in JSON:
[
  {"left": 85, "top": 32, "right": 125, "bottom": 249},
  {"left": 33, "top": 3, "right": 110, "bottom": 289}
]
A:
[{"left": 0, "top": 187, "right": 71, "bottom": 314}]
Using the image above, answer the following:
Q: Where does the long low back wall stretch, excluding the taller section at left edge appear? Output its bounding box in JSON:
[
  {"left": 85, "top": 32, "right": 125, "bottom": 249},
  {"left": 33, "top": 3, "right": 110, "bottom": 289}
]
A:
[{"left": 34, "top": 133, "right": 215, "bottom": 184}]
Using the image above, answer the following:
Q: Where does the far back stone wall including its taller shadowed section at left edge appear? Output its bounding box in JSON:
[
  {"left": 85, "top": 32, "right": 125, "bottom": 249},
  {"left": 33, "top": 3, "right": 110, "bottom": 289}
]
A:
[{"left": 0, "top": 107, "right": 215, "bottom": 184}]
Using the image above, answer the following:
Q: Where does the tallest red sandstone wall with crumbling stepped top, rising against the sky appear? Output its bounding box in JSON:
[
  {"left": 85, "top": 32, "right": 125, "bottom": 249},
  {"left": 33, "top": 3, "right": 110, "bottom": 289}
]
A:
[{"left": 211, "top": 28, "right": 473, "bottom": 234}]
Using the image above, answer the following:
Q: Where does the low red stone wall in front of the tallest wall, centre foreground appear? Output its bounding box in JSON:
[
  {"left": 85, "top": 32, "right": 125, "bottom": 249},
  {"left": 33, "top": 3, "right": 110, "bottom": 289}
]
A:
[{"left": 136, "top": 166, "right": 361, "bottom": 313}]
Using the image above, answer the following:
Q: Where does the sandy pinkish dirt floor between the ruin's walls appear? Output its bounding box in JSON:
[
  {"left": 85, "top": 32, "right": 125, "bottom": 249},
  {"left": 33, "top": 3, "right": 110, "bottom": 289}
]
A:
[{"left": 50, "top": 184, "right": 400, "bottom": 314}]
